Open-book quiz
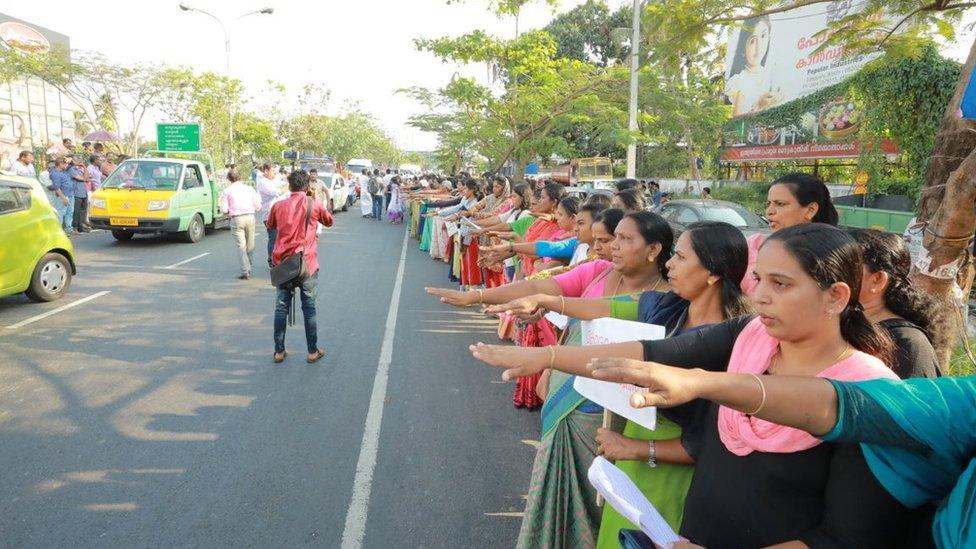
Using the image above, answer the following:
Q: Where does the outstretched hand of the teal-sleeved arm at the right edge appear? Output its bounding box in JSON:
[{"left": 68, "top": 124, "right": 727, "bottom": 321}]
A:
[{"left": 587, "top": 358, "right": 705, "bottom": 408}]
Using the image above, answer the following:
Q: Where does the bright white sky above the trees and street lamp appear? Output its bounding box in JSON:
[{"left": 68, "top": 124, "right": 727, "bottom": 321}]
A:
[{"left": 0, "top": 0, "right": 976, "bottom": 150}]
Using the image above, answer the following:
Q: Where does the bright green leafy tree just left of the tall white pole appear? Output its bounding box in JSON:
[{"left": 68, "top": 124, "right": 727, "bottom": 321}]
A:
[{"left": 416, "top": 31, "right": 631, "bottom": 177}]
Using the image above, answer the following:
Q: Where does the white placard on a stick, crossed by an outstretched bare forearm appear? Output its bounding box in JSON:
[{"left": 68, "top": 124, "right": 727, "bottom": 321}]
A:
[{"left": 573, "top": 318, "right": 664, "bottom": 429}]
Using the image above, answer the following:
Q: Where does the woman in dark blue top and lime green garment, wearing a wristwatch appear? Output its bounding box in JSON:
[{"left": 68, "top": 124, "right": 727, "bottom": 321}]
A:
[{"left": 484, "top": 222, "right": 749, "bottom": 548}]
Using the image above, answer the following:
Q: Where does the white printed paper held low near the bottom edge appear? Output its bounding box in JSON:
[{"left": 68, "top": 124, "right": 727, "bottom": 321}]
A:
[{"left": 587, "top": 456, "right": 681, "bottom": 547}]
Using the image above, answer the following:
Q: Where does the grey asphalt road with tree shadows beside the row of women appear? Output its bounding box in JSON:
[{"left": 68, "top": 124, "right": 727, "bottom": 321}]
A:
[{"left": 0, "top": 211, "right": 539, "bottom": 547}]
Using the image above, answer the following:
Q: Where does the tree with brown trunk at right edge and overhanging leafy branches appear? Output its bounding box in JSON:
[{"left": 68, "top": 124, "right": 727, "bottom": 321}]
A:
[{"left": 642, "top": 0, "right": 976, "bottom": 365}]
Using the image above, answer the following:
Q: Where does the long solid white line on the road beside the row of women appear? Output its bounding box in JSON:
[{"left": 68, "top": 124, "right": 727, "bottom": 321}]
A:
[{"left": 341, "top": 231, "right": 410, "bottom": 549}]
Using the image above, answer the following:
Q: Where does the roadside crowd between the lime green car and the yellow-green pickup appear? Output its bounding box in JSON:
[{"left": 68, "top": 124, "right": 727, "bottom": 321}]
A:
[{"left": 8, "top": 138, "right": 124, "bottom": 236}]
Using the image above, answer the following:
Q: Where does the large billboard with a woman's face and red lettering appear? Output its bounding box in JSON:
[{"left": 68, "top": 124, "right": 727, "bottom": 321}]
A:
[{"left": 722, "top": 0, "right": 897, "bottom": 162}]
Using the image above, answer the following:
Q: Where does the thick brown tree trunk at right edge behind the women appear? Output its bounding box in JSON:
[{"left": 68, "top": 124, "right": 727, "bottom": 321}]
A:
[{"left": 912, "top": 36, "right": 976, "bottom": 370}]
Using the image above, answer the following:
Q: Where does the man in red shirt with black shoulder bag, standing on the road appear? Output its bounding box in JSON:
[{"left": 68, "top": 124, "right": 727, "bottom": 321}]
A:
[{"left": 265, "top": 170, "right": 332, "bottom": 364}]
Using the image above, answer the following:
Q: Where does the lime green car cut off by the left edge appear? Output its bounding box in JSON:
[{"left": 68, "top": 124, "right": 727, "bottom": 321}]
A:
[{"left": 0, "top": 175, "right": 76, "bottom": 301}]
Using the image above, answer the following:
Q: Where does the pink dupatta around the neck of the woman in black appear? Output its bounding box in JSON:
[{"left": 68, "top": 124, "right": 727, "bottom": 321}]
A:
[{"left": 718, "top": 318, "right": 898, "bottom": 456}]
